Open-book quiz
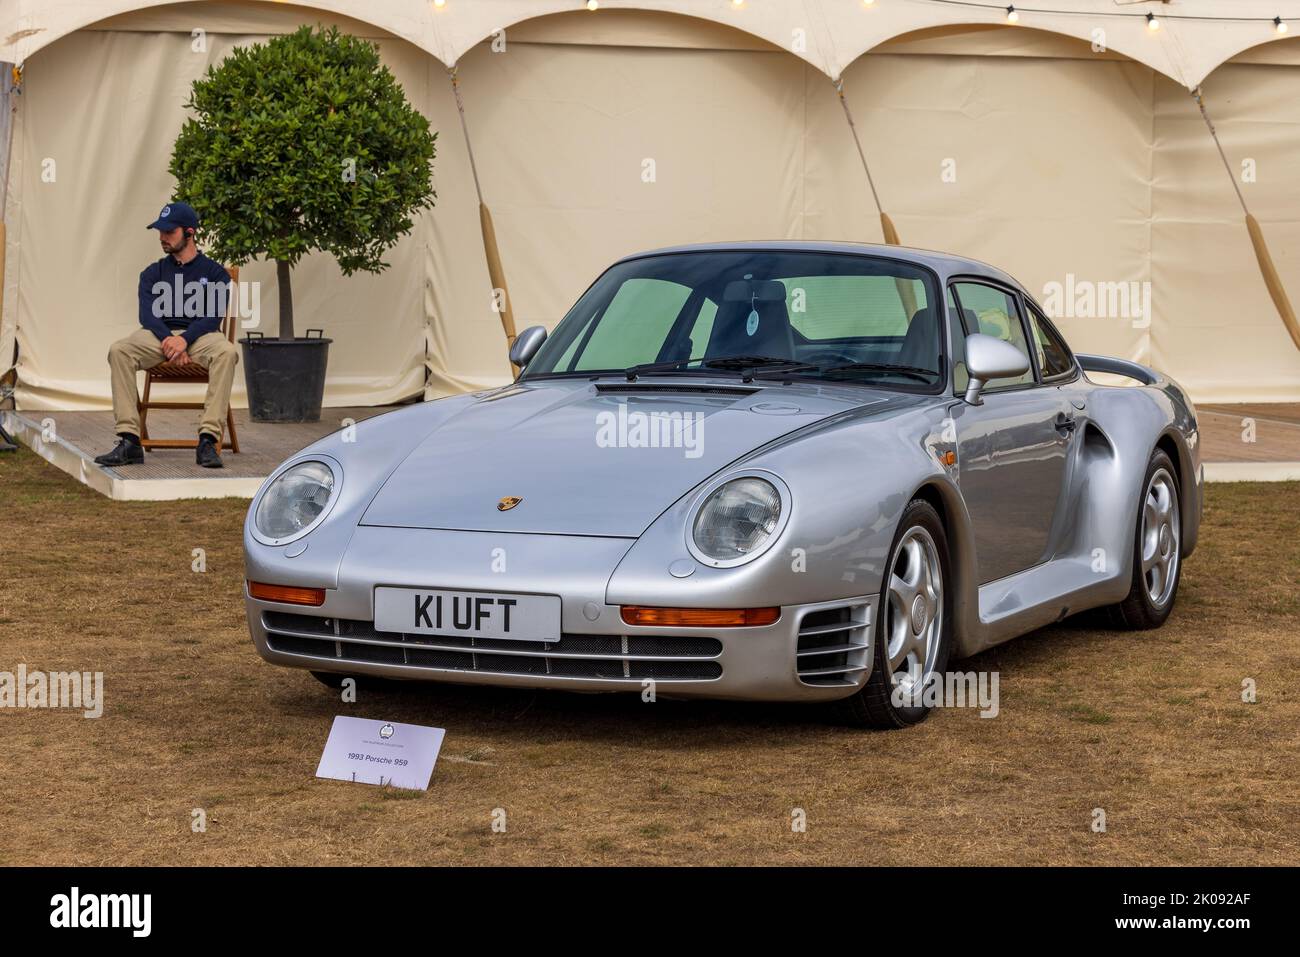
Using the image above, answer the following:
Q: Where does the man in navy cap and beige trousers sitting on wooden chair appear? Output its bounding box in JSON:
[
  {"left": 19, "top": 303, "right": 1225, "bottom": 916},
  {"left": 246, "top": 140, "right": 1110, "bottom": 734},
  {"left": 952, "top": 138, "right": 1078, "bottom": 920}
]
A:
[{"left": 95, "top": 203, "right": 239, "bottom": 468}]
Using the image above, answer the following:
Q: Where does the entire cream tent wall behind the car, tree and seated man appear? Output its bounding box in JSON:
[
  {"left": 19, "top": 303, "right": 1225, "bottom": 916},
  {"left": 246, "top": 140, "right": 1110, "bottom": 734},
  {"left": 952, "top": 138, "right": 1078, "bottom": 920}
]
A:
[{"left": 0, "top": 9, "right": 1300, "bottom": 408}]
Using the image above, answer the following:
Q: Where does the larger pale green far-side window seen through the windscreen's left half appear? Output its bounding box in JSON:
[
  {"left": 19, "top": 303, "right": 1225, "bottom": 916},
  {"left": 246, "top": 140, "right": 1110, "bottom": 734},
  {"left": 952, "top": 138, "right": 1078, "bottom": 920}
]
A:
[{"left": 563, "top": 278, "right": 690, "bottom": 372}]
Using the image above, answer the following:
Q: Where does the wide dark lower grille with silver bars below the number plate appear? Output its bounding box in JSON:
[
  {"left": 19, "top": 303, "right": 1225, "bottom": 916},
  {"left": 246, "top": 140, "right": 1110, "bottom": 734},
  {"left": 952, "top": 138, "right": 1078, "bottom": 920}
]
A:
[{"left": 261, "top": 611, "right": 723, "bottom": 681}]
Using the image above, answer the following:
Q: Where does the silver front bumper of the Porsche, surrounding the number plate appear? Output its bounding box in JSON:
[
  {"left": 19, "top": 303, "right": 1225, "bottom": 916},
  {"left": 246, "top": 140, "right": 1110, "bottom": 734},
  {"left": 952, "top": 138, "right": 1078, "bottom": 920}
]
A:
[{"left": 244, "top": 528, "right": 876, "bottom": 701}]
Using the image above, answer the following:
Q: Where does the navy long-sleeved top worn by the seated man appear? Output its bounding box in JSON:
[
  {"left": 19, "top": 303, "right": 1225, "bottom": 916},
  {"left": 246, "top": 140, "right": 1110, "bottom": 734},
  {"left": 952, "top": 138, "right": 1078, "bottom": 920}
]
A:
[{"left": 139, "top": 252, "right": 233, "bottom": 347}]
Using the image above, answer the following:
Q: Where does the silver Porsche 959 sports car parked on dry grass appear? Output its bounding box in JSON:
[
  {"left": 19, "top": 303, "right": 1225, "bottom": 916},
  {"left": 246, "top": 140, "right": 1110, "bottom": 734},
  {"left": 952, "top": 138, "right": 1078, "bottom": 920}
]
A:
[{"left": 244, "top": 242, "right": 1204, "bottom": 727}]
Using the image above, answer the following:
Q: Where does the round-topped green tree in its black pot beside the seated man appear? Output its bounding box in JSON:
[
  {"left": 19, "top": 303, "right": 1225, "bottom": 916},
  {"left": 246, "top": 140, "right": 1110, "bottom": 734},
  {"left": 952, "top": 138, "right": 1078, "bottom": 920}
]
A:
[{"left": 170, "top": 26, "right": 437, "bottom": 421}]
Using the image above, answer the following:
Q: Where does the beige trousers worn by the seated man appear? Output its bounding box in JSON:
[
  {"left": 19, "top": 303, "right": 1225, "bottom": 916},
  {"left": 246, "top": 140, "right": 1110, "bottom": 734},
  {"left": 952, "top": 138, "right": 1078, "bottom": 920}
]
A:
[{"left": 108, "top": 326, "right": 239, "bottom": 442}]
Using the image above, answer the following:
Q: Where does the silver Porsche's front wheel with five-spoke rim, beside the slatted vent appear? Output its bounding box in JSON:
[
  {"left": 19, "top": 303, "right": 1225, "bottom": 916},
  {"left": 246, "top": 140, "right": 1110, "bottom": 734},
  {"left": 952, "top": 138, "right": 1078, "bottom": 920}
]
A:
[{"left": 832, "top": 498, "right": 952, "bottom": 728}]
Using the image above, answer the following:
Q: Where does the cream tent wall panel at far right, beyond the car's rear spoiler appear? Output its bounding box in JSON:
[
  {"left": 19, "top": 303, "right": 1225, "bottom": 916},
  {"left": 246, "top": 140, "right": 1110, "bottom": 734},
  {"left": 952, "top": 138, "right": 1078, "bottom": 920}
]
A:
[{"left": 1149, "top": 64, "right": 1300, "bottom": 402}]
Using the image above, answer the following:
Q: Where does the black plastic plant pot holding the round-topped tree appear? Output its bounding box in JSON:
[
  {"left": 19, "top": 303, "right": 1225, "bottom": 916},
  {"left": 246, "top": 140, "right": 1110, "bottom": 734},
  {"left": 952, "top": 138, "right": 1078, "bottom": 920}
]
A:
[{"left": 239, "top": 329, "right": 332, "bottom": 423}]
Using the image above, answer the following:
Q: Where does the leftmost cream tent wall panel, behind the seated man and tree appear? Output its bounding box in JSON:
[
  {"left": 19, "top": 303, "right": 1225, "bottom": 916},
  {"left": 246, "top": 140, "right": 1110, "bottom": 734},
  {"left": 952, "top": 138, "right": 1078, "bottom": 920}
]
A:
[{"left": 10, "top": 31, "right": 426, "bottom": 408}]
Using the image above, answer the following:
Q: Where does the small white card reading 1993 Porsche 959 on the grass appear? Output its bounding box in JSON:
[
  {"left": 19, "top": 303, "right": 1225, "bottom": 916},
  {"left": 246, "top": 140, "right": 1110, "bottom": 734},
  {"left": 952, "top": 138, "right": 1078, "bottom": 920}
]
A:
[{"left": 316, "top": 715, "right": 447, "bottom": 791}]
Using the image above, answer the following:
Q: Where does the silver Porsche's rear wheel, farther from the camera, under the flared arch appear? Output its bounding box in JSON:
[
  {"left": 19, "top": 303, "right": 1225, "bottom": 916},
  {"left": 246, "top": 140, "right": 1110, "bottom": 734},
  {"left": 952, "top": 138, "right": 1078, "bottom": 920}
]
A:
[{"left": 1109, "top": 449, "right": 1183, "bottom": 631}]
